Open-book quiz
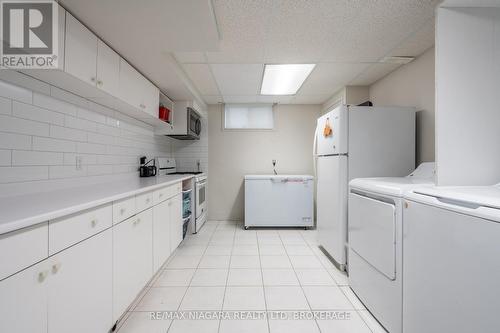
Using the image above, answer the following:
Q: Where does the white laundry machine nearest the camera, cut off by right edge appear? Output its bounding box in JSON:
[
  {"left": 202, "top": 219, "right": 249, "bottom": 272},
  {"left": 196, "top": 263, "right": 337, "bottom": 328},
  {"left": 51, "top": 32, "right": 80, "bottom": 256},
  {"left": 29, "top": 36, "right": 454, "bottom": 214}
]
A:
[{"left": 403, "top": 185, "right": 500, "bottom": 333}]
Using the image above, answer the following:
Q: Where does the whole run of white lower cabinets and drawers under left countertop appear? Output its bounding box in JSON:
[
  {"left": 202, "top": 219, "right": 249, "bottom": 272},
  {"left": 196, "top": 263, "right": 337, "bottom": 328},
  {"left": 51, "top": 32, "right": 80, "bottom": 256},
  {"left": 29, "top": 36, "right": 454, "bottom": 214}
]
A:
[{"left": 0, "top": 182, "right": 183, "bottom": 333}]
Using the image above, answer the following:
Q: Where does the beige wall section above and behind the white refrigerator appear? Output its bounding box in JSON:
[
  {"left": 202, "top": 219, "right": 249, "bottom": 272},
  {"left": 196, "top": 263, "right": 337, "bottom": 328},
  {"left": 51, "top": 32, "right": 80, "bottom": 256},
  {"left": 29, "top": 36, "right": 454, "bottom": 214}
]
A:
[{"left": 370, "top": 48, "right": 435, "bottom": 163}]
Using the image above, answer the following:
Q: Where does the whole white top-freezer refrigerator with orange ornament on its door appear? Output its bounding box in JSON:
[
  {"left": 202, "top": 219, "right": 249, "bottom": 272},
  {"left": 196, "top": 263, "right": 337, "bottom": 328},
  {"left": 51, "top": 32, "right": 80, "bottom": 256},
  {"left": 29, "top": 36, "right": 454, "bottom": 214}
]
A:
[{"left": 313, "top": 105, "right": 415, "bottom": 269}]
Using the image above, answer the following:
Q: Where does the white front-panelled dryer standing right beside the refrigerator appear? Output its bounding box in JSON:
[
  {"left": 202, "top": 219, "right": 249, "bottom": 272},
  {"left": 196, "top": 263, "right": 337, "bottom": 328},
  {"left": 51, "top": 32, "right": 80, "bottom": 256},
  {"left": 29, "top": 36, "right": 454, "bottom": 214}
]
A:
[{"left": 348, "top": 163, "right": 435, "bottom": 333}]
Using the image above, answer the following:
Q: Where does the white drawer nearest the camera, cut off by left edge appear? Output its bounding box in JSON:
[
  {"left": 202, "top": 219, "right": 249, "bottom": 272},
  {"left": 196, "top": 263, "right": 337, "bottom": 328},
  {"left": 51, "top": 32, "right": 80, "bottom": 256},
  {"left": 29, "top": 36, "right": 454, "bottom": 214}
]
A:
[{"left": 0, "top": 222, "right": 49, "bottom": 280}]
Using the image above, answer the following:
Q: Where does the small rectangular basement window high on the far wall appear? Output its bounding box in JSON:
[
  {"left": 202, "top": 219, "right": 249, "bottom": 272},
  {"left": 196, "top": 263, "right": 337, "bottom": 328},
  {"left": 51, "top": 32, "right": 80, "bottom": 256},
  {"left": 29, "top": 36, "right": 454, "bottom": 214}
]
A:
[{"left": 224, "top": 104, "right": 274, "bottom": 130}]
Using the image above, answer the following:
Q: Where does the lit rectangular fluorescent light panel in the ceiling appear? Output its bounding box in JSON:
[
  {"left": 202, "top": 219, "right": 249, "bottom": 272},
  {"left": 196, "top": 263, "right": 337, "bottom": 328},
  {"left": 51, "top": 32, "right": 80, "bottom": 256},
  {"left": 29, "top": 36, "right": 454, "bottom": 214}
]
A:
[{"left": 260, "top": 64, "right": 316, "bottom": 95}]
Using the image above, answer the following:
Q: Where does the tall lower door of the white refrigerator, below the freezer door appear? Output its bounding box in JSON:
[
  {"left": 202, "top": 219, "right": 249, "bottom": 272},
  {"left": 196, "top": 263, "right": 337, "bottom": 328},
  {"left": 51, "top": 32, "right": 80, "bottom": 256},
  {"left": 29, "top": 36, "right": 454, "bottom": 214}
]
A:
[{"left": 317, "top": 155, "right": 347, "bottom": 265}]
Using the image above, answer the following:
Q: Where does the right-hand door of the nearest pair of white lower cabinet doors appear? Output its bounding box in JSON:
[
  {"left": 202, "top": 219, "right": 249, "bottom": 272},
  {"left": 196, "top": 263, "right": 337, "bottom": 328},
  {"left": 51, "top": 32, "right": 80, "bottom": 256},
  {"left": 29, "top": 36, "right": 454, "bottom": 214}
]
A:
[{"left": 48, "top": 229, "right": 113, "bottom": 333}]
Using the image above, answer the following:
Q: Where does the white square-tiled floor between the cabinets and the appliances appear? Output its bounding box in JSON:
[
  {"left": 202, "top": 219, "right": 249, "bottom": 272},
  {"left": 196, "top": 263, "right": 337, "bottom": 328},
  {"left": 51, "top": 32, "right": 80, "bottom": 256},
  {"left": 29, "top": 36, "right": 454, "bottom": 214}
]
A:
[{"left": 118, "top": 221, "right": 385, "bottom": 333}]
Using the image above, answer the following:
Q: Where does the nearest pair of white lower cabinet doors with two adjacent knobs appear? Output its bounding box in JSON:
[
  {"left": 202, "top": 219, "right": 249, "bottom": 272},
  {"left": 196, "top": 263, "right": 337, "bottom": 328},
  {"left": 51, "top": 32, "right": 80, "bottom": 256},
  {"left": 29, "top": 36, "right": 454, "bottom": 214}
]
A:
[{"left": 0, "top": 230, "right": 113, "bottom": 333}]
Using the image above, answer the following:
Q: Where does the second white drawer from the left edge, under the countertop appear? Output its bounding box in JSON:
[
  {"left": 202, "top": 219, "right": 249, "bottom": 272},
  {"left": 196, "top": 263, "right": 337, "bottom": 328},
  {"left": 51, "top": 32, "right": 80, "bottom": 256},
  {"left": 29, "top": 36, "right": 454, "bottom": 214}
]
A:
[{"left": 49, "top": 204, "right": 113, "bottom": 255}]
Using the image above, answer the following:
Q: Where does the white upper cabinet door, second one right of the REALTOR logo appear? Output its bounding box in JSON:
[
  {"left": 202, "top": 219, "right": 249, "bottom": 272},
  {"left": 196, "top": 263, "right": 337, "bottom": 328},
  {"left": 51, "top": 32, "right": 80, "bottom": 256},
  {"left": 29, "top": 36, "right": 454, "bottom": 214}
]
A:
[{"left": 97, "top": 40, "right": 120, "bottom": 96}]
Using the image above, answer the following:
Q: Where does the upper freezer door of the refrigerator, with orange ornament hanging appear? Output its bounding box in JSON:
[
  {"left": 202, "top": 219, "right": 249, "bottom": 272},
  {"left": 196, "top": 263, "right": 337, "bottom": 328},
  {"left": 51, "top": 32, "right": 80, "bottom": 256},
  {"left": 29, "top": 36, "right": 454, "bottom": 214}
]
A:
[{"left": 316, "top": 105, "right": 347, "bottom": 156}]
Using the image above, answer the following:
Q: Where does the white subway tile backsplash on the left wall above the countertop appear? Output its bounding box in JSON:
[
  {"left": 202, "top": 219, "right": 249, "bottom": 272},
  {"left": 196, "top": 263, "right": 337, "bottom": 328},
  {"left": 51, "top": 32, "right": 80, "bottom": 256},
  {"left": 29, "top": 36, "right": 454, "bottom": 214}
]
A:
[{"left": 0, "top": 76, "right": 208, "bottom": 189}]
